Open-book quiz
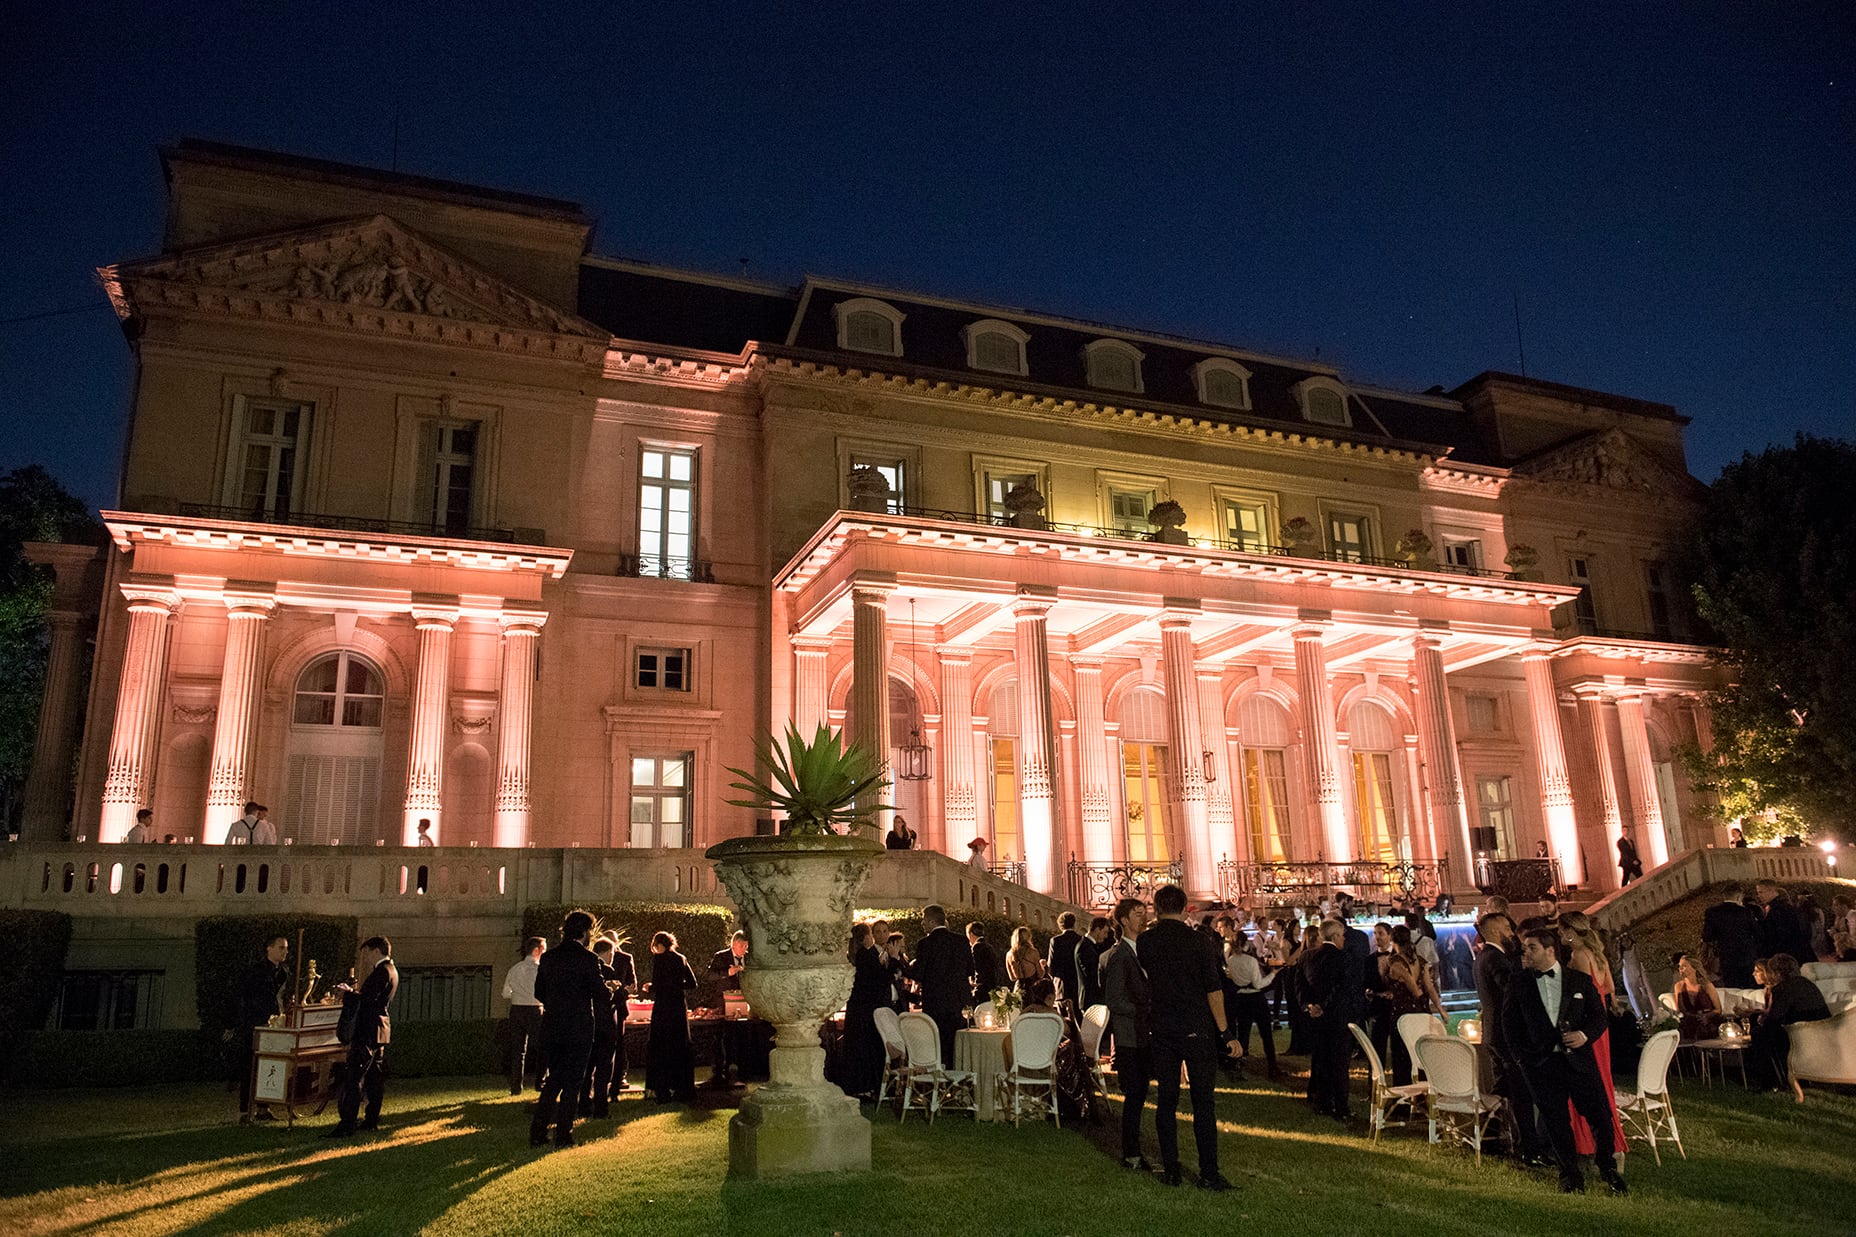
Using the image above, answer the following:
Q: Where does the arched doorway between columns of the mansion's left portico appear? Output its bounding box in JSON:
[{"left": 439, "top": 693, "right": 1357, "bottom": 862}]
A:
[{"left": 278, "top": 648, "right": 386, "bottom": 845}]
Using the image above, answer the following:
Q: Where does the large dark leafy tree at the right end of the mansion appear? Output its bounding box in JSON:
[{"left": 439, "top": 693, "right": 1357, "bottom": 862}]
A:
[{"left": 1687, "top": 435, "right": 1856, "bottom": 838}]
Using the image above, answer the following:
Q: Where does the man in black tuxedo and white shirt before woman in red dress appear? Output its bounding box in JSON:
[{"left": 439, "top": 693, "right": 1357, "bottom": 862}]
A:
[{"left": 1502, "top": 929, "right": 1626, "bottom": 1194}]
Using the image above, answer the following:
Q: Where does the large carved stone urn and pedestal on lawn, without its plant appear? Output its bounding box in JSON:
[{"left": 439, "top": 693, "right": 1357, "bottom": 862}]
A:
[{"left": 709, "top": 834, "right": 883, "bottom": 1178}]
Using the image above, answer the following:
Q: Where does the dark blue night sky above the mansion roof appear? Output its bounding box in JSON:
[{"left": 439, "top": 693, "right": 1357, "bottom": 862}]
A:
[{"left": 0, "top": 0, "right": 1856, "bottom": 503}]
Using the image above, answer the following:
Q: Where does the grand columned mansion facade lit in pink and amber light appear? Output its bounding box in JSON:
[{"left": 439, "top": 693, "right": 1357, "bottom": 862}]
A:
[{"left": 24, "top": 143, "right": 1724, "bottom": 893}]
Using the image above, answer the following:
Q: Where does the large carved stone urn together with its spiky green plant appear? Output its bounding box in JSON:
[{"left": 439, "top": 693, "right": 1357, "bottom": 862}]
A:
[{"left": 707, "top": 726, "right": 889, "bottom": 1178}]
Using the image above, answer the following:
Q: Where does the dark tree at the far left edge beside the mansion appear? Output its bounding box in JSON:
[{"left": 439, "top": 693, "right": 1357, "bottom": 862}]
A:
[{"left": 0, "top": 464, "right": 104, "bottom": 828}]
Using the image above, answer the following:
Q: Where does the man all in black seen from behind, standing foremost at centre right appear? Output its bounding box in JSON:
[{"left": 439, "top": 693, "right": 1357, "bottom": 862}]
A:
[{"left": 1136, "top": 884, "right": 1231, "bottom": 1191}]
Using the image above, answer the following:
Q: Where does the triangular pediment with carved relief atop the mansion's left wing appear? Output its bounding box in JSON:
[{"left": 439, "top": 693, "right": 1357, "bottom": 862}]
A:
[{"left": 102, "top": 215, "right": 611, "bottom": 351}]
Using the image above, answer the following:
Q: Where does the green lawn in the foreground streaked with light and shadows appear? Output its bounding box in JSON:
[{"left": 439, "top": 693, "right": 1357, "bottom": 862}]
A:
[{"left": 0, "top": 1047, "right": 1856, "bottom": 1237}]
